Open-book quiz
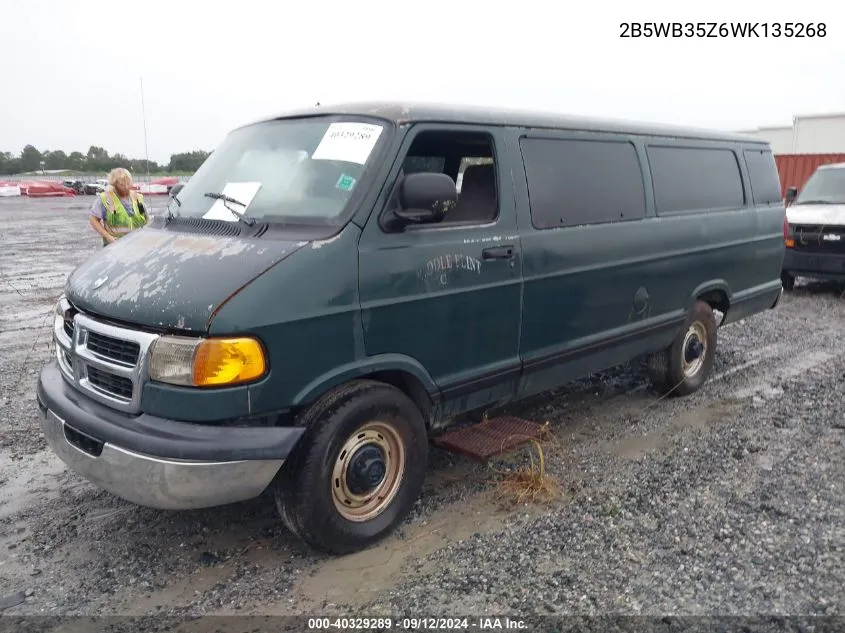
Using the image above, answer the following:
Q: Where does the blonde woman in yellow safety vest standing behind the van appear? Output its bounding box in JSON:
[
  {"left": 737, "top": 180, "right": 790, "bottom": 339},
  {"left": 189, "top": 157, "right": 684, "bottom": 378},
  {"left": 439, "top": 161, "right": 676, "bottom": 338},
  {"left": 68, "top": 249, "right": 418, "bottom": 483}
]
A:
[{"left": 89, "top": 167, "right": 149, "bottom": 246}]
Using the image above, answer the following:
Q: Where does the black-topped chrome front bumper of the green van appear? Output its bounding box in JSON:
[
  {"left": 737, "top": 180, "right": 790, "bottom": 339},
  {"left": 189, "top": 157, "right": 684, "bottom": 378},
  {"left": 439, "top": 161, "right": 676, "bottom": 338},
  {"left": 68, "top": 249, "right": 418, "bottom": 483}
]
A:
[{"left": 38, "top": 361, "right": 305, "bottom": 510}]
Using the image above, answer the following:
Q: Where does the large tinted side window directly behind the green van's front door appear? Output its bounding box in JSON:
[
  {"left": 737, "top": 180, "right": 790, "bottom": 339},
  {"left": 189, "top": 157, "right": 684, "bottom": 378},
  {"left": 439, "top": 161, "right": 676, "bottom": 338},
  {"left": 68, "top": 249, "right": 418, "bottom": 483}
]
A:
[{"left": 520, "top": 138, "right": 645, "bottom": 229}]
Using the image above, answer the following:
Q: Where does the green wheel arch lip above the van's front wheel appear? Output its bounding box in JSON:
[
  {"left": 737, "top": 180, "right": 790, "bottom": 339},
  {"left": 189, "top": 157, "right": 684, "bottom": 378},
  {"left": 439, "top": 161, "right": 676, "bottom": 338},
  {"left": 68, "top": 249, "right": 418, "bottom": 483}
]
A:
[{"left": 293, "top": 354, "right": 440, "bottom": 406}]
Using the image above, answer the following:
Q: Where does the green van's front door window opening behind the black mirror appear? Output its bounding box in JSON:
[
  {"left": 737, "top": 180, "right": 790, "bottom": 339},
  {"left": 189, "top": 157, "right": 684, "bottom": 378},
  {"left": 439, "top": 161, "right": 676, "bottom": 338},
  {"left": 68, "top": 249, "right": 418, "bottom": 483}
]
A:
[{"left": 382, "top": 131, "right": 499, "bottom": 231}]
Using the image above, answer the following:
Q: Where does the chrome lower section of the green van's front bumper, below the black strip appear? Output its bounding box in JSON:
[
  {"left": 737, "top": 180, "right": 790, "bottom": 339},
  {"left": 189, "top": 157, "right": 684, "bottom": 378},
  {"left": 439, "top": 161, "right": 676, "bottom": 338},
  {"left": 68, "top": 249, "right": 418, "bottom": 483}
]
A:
[{"left": 41, "top": 408, "right": 284, "bottom": 510}]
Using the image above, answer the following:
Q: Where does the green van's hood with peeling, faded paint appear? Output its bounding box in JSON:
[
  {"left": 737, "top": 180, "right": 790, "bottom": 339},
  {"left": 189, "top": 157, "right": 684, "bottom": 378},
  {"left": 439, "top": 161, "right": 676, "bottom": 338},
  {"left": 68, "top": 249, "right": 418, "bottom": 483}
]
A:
[{"left": 65, "top": 227, "right": 307, "bottom": 332}]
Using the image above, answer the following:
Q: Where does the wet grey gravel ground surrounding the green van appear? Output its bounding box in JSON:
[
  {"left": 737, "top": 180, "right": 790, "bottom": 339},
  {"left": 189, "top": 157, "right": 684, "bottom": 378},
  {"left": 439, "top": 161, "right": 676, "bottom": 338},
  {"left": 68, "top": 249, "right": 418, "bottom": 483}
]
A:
[{"left": 0, "top": 198, "right": 845, "bottom": 630}]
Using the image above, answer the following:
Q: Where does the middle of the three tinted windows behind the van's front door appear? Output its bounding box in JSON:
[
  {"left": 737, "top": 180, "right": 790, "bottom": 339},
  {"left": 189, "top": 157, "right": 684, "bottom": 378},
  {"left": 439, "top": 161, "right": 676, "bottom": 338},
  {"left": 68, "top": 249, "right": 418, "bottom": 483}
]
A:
[{"left": 647, "top": 146, "right": 745, "bottom": 215}]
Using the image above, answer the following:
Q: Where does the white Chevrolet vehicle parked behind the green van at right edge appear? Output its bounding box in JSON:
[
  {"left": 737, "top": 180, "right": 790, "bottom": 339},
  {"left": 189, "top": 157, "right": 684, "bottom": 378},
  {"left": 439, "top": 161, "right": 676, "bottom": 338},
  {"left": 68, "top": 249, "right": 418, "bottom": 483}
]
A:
[{"left": 781, "top": 163, "right": 845, "bottom": 290}]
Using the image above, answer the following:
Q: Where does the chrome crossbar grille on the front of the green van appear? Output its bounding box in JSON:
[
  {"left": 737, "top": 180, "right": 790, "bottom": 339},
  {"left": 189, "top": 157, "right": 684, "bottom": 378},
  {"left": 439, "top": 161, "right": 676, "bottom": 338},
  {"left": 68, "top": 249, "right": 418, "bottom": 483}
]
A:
[{"left": 53, "top": 299, "right": 158, "bottom": 413}]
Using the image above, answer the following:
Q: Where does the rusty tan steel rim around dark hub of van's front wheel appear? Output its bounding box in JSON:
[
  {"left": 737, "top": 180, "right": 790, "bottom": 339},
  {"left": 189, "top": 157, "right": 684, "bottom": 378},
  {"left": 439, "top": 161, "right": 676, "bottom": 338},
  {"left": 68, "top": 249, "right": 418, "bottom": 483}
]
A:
[{"left": 331, "top": 422, "right": 405, "bottom": 522}]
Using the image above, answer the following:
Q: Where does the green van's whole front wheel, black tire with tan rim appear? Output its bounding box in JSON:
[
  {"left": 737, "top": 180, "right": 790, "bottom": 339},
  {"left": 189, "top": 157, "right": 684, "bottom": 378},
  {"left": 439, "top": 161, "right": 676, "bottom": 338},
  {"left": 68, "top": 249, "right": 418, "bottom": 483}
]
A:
[{"left": 275, "top": 380, "right": 428, "bottom": 554}]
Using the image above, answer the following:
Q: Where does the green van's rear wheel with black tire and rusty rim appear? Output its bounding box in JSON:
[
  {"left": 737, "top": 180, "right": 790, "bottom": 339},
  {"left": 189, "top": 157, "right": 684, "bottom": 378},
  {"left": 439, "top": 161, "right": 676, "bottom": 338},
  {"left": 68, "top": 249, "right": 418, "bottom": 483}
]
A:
[{"left": 646, "top": 300, "right": 717, "bottom": 396}]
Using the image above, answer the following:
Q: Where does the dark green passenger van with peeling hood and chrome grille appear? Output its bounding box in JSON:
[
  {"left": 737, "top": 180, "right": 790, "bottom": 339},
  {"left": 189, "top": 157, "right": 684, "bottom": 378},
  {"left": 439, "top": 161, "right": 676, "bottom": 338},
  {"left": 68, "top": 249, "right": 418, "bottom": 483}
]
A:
[{"left": 37, "top": 103, "right": 785, "bottom": 554}]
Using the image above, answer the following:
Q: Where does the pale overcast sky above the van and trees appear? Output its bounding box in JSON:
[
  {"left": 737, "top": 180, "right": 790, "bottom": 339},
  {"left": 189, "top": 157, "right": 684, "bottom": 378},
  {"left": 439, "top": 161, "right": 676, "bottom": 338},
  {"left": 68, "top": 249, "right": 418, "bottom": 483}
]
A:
[{"left": 0, "top": 0, "right": 845, "bottom": 162}]
